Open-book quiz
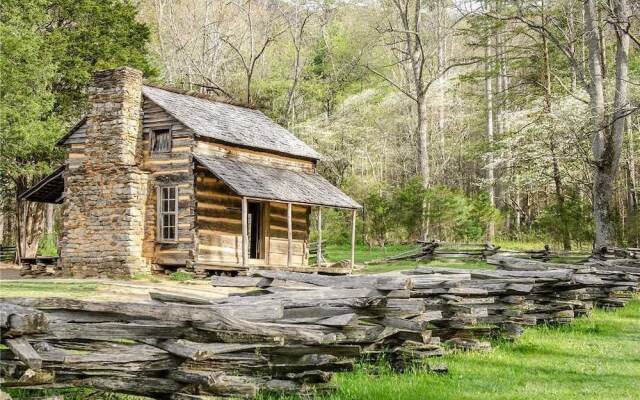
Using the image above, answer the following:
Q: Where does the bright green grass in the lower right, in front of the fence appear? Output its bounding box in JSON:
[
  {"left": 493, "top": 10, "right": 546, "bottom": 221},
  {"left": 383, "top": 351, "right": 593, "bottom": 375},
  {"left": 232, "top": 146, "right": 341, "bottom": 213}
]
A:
[{"left": 308, "top": 300, "right": 640, "bottom": 400}]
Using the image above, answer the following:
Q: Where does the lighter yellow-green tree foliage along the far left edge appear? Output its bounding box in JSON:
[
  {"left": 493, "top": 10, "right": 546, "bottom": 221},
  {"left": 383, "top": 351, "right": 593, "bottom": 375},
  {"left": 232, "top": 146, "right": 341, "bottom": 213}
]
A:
[{"left": 0, "top": 1, "right": 61, "bottom": 194}]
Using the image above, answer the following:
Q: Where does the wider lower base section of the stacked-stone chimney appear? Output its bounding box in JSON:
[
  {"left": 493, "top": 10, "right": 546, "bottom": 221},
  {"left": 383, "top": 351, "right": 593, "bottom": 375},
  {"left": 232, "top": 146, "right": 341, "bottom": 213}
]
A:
[{"left": 61, "top": 170, "right": 148, "bottom": 277}]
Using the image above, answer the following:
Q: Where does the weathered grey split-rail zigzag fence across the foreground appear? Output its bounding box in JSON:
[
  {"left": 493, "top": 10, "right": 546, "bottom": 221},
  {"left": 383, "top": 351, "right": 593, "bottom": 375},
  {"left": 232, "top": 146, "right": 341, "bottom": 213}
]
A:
[{"left": 0, "top": 253, "right": 640, "bottom": 399}]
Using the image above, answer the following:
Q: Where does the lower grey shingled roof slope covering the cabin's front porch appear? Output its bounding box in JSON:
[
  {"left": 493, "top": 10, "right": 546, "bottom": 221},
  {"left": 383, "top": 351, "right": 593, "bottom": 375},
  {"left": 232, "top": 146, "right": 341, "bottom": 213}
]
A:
[{"left": 193, "top": 153, "right": 361, "bottom": 208}]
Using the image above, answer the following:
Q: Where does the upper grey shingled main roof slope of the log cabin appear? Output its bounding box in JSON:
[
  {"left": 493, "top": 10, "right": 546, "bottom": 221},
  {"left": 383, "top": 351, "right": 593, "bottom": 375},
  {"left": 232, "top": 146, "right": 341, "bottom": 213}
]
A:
[{"left": 142, "top": 85, "right": 320, "bottom": 160}]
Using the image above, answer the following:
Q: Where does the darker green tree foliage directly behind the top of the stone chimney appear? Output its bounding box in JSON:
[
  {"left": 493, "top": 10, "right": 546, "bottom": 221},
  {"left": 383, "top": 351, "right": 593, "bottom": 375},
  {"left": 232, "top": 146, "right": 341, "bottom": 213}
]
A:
[{"left": 45, "top": 0, "right": 155, "bottom": 118}]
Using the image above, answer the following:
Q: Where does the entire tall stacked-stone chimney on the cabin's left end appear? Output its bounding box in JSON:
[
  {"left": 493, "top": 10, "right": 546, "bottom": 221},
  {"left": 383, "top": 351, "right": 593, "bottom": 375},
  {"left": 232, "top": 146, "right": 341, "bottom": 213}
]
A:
[{"left": 60, "top": 67, "right": 148, "bottom": 277}]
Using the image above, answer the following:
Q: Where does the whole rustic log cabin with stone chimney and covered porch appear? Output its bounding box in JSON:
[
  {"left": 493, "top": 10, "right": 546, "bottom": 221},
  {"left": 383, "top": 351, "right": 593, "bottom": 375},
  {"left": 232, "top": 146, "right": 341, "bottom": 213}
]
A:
[{"left": 21, "top": 67, "right": 360, "bottom": 276}]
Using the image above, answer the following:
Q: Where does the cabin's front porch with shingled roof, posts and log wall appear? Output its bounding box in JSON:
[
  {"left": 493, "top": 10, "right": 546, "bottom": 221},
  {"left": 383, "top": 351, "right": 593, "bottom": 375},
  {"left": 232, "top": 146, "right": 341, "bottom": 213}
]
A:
[{"left": 194, "top": 154, "right": 360, "bottom": 274}]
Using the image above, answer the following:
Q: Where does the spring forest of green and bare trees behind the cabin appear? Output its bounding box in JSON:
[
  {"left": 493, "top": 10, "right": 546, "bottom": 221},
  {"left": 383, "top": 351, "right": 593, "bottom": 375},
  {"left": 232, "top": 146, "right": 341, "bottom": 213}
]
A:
[{"left": 0, "top": 0, "right": 640, "bottom": 256}]
